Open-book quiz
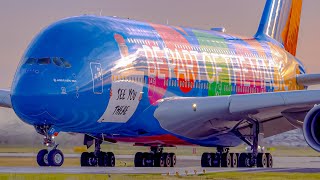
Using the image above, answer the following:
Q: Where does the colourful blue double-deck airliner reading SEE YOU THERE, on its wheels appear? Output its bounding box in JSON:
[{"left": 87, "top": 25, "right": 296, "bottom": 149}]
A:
[{"left": 1, "top": 0, "right": 320, "bottom": 167}]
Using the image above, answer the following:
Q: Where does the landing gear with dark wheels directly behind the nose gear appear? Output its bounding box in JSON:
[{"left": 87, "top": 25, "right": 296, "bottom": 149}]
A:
[{"left": 80, "top": 135, "right": 116, "bottom": 167}]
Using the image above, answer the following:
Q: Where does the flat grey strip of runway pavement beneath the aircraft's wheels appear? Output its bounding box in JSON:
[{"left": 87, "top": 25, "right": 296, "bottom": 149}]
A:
[{"left": 0, "top": 166, "right": 320, "bottom": 175}]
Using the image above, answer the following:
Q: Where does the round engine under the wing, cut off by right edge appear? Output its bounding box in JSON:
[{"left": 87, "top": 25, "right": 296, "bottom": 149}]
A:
[{"left": 303, "top": 105, "right": 320, "bottom": 152}]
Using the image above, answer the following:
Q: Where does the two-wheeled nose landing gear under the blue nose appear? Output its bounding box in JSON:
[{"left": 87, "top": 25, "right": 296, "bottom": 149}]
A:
[{"left": 35, "top": 126, "right": 64, "bottom": 166}]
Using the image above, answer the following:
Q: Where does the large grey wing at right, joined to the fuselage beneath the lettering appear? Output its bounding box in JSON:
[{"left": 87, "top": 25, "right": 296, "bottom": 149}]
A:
[{"left": 154, "top": 90, "right": 320, "bottom": 139}]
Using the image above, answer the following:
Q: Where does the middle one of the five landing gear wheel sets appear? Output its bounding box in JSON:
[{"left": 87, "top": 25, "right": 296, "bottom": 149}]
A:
[{"left": 134, "top": 147, "right": 177, "bottom": 167}]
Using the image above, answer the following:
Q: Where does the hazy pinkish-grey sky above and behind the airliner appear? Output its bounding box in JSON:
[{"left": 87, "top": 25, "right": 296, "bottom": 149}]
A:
[{"left": 0, "top": 0, "right": 320, "bottom": 88}]
